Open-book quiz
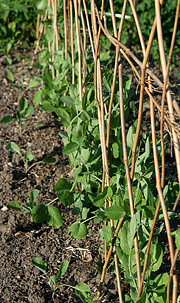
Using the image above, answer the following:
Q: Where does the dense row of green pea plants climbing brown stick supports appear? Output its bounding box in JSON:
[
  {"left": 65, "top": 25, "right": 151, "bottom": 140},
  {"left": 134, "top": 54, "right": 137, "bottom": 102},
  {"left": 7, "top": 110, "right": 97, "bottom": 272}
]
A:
[{"left": 25, "top": 0, "right": 180, "bottom": 303}]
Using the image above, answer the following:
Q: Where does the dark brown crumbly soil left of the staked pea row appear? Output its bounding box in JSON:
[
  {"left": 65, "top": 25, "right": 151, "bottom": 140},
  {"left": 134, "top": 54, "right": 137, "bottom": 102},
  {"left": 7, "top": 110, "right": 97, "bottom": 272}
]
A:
[{"left": 0, "top": 49, "right": 180, "bottom": 303}]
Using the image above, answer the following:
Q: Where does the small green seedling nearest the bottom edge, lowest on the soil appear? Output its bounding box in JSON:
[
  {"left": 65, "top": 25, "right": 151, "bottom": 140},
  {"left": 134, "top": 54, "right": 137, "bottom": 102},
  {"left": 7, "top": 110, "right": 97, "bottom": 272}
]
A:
[{"left": 31, "top": 258, "right": 97, "bottom": 303}]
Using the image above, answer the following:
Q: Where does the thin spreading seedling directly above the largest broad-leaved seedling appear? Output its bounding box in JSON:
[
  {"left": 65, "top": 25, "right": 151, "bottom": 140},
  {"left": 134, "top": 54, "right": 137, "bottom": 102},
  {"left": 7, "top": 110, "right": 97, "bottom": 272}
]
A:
[{"left": 6, "top": 142, "right": 56, "bottom": 173}]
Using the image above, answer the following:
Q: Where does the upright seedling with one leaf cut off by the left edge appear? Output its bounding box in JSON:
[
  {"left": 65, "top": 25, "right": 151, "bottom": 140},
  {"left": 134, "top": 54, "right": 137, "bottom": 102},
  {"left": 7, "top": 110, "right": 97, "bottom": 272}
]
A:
[{"left": 0, "top": 97, "right": 34, "bottom": 133}]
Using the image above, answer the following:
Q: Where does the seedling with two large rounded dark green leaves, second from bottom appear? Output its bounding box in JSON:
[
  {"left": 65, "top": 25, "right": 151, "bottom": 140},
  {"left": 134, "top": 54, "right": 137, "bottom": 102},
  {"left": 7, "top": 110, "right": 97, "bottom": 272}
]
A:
[{"left": 8, "top": 189, "right": 63, "bottom": 228}]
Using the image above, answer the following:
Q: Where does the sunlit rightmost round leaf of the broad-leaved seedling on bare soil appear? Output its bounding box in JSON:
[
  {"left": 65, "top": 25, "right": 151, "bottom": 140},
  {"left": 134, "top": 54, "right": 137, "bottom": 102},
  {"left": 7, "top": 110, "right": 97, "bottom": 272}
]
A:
[{"left": 46, "top": 205, "right": 63, "bottom": 228}]
